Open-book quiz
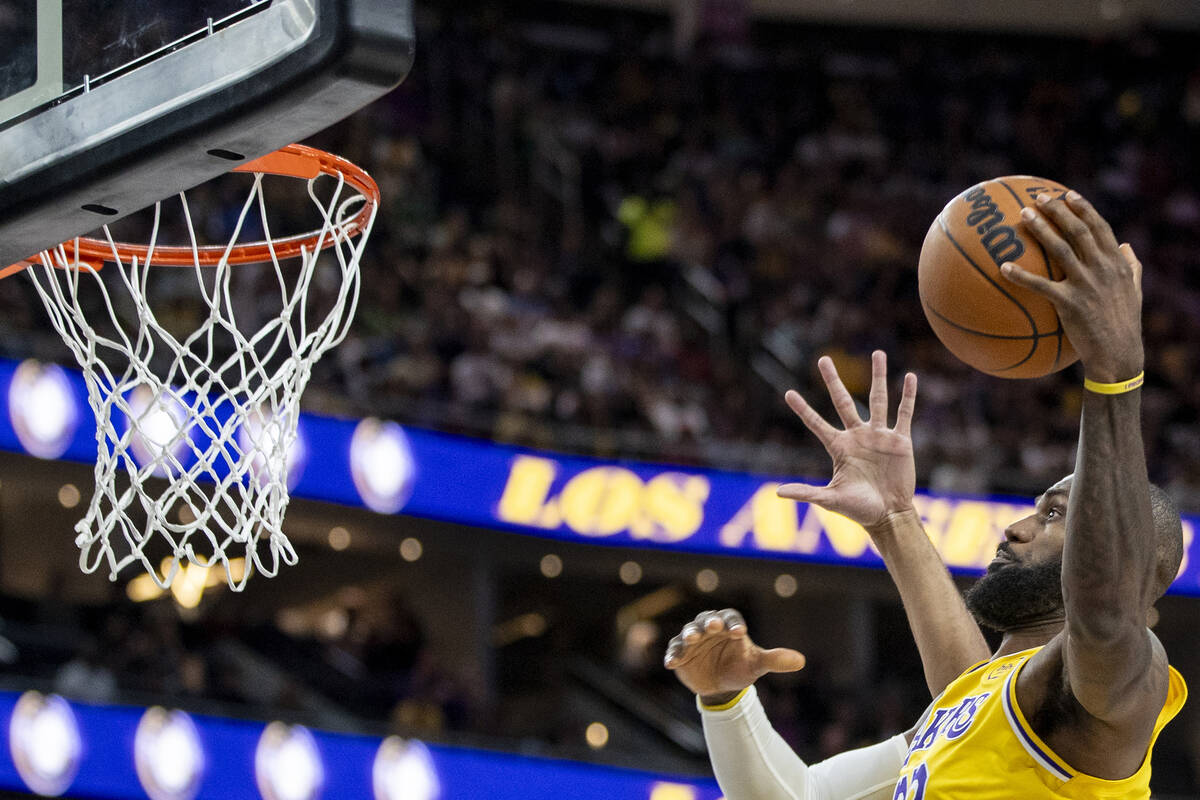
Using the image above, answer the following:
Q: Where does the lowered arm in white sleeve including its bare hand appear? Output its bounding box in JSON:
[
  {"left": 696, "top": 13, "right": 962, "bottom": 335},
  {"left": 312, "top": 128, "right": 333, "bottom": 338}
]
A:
[{"left": 665, "top": 608, "right": 912, "bottom": 800}]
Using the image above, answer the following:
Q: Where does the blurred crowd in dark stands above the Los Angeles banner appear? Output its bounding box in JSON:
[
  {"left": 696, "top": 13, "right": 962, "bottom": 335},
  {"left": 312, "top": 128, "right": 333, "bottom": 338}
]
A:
[{"left": 0, "top": 2, "right": 1200, "bottom": 510}]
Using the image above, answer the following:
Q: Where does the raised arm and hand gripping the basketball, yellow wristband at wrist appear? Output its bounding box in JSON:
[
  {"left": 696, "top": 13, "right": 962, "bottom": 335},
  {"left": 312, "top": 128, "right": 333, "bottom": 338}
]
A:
[{"left": 1004, "top": 193, "right": 1166, "bottom": 727}]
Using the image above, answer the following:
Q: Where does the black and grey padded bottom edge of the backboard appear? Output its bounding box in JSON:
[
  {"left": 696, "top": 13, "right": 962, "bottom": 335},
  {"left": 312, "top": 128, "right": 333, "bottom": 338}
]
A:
[{"left": 0, "top": 0, "right": 415, "bottom": 266}]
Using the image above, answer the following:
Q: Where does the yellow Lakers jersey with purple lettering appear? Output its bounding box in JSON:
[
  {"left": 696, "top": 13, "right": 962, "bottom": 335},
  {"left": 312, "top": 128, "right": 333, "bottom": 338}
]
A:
[{"left": 893, "top": 648, "right": 1188, "bottom": 800}]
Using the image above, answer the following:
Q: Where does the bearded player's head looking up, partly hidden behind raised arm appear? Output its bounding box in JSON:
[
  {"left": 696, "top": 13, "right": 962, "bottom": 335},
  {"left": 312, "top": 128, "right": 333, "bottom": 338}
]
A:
[{"left": 966, "top": 475, "right": 1183, "bottom": 631}]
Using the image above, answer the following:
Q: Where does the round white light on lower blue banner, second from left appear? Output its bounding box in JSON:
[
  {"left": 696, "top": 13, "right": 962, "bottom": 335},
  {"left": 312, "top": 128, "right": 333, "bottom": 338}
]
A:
[{"left": 133, "top": 706, "right": 205, "bottom": 800}]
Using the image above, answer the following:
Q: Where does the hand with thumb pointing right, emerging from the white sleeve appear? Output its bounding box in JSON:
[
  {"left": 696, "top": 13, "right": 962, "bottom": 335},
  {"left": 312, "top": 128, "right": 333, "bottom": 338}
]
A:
[{"left": 662, "top": 608, "right": 804, "bottom": 705}]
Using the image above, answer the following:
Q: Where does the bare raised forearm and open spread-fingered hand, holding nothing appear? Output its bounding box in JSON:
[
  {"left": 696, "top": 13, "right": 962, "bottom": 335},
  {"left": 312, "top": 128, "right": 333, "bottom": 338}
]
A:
[{"left": 779, "top": 351, "right": 990, "bottom": 697}]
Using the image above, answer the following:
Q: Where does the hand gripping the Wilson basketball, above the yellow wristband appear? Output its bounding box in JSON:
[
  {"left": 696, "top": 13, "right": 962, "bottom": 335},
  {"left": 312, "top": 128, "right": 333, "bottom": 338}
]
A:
[{"left": 1001, "top": 192, "right": 1145, "bottom": 383}]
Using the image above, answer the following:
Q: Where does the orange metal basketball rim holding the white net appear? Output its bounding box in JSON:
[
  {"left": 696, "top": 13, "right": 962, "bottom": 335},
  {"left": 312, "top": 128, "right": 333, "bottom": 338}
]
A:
[{"left": 30, "top": 144, "right": 379, "bottom": 271}]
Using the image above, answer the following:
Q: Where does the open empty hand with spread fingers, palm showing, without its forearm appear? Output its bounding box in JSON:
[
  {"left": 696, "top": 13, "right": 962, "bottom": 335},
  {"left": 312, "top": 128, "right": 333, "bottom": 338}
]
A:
[{"left": 778, "top": 350, "right": 917, "bottom": 528}]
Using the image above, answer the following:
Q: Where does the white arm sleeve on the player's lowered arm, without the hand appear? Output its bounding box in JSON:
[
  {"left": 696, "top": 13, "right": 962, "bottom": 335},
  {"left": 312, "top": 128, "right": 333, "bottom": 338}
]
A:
[{"left": 696, "top": 686, "right": 908, "bottom": 800}]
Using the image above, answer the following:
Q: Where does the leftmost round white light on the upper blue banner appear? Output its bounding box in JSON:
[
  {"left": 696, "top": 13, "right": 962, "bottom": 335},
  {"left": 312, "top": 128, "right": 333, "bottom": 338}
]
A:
[{"left": 8, "top": 359, "right": 79, "bottom": 458}]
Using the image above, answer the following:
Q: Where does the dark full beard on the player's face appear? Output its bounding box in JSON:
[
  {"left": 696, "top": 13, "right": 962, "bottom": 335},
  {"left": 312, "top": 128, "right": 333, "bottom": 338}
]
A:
[{"left": 964, "top": 558, "right": 1063, "bottom": 632}]
